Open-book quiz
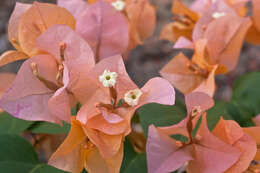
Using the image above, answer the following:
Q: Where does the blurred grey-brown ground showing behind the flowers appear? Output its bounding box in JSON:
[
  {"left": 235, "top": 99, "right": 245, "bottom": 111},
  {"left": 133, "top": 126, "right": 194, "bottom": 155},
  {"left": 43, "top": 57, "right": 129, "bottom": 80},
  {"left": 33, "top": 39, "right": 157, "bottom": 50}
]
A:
[{"left": 0, "top": 0, "right": 260, "bottom": 101}]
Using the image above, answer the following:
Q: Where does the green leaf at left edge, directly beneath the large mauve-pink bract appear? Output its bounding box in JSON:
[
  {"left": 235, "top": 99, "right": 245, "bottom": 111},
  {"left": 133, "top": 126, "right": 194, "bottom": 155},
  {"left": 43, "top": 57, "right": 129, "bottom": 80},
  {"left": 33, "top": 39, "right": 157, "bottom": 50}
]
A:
[{"left": 0, "top": 112, "right": 34, "bottom": 134}]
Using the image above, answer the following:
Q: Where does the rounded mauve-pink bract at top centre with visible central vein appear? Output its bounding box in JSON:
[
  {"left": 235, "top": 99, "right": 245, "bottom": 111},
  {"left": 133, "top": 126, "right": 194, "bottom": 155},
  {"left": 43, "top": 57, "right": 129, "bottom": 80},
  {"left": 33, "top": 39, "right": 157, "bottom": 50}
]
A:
[{"left": 76, "top": 0, "right": 129, "bottom": 61}]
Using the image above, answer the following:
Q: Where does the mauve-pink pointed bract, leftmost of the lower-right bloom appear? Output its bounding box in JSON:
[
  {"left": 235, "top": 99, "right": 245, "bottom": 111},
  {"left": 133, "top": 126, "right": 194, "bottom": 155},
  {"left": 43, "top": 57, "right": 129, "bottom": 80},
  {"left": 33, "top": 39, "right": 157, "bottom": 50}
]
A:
[{"left": 146, "top": 125, "right": 192, "bottom": 173}]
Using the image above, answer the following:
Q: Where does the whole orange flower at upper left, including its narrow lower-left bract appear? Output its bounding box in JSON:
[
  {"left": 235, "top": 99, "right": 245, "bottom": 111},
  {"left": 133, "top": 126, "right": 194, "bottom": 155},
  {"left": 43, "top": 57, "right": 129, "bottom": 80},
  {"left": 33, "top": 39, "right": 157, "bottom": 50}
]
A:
[{"left": 0, "top": 2, "right": 75, "bottom": 65}]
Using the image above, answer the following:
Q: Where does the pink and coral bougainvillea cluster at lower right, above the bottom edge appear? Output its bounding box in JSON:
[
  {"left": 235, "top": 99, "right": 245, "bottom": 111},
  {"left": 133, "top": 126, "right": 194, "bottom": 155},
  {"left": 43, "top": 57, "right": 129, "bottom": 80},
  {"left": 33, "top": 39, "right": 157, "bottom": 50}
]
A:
[{"left": 147, "top": 92, "right": 256, "bottom": 173}]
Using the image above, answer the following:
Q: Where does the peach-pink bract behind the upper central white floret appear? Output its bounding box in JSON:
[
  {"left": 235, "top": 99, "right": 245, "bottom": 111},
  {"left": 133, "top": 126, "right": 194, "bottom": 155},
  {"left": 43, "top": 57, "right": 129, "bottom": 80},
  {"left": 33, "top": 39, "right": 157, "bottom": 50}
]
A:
[{"left": 72, "top": 55, "right": 138, "bottom": 105}]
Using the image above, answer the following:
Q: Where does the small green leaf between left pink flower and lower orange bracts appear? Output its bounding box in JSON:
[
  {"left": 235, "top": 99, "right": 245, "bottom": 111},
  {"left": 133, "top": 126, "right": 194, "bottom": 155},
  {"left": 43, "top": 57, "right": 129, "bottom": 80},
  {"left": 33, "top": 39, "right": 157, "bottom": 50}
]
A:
[{"left": 29, "top": 122, "right": 70, "bottom": 134}]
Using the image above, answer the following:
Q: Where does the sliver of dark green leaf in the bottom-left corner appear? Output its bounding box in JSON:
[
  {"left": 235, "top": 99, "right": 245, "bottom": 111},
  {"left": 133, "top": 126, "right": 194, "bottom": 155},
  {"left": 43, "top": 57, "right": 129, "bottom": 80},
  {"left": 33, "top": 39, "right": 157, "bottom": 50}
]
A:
[{"left": 0, "top": 161, "right": 34, "bottom": 173}]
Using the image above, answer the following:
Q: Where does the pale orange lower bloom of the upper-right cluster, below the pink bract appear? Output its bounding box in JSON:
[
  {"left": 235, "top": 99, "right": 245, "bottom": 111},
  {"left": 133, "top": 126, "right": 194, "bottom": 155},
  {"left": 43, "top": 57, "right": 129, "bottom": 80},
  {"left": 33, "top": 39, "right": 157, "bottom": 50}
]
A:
[{"left": 160, "top": 40, "right": 218, "bottom": 96}]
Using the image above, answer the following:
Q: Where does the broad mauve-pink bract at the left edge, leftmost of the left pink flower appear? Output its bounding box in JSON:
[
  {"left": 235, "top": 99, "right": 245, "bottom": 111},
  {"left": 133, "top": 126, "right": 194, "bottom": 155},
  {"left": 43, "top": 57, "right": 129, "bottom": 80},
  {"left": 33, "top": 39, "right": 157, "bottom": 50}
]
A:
[{"left": 0, "top": 55, "right": 57, "bottom": 122}]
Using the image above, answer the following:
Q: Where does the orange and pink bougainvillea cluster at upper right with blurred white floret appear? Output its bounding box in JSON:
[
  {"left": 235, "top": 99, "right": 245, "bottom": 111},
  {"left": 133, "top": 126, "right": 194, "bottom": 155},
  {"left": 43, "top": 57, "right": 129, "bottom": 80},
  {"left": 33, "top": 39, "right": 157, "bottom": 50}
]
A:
[{"left": 161, "top": 0, "right": 252, "bottom": 96}]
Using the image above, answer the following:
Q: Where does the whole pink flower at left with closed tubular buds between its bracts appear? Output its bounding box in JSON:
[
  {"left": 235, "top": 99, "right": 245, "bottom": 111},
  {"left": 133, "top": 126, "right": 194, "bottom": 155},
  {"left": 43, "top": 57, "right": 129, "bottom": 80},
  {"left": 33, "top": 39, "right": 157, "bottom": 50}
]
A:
[{"left": 0, "top": 25, "right": 95, "bottom": 123}]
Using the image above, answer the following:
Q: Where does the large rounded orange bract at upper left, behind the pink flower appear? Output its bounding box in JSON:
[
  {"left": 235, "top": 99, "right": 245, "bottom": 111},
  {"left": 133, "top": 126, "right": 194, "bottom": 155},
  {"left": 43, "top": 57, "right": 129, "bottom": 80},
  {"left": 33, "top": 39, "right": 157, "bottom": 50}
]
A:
[{"left": 18, "top": 2, "right": 75, "bottom": 56}]
